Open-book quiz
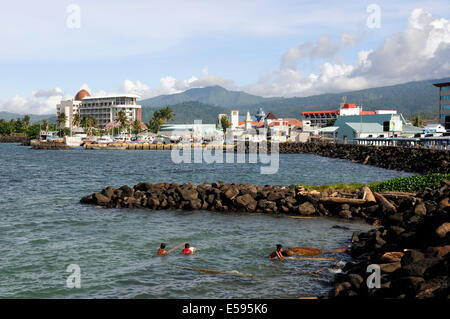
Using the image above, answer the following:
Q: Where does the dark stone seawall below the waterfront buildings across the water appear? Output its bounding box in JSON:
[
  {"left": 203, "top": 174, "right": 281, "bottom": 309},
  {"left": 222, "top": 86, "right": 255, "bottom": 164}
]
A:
[{"left": 279, "top": 143, "right": 450, "bottom": 174}]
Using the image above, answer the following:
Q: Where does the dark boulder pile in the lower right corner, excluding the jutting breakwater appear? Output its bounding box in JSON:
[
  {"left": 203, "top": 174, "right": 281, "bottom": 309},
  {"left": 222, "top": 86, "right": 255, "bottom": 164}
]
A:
[{"left": 331, "top": 180, "right": 450, "bottom": 299}]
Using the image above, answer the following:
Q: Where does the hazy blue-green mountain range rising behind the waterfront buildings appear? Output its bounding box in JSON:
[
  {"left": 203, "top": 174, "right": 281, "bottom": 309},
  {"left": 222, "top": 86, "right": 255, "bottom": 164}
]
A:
[{"left": 0, "top": 78, "right": 450, "bottom": 123}]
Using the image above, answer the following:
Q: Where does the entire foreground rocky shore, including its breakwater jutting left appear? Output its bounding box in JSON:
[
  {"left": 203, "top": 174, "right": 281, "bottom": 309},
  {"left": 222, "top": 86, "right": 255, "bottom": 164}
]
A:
[{"left": 80, "top": 180, "right": 450, "bottom": 299}]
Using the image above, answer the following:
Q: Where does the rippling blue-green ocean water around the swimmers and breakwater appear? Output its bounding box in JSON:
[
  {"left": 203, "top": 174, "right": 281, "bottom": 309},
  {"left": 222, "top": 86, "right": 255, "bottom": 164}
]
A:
[{"left": 0, "top": 144, "right": 410, "bottom": 298}]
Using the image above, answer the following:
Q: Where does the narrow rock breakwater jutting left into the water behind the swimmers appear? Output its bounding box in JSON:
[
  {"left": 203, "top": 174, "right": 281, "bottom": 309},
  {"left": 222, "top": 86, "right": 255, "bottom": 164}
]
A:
[{"left": 81, "top": 181, "right": 381, "bottom": 223}]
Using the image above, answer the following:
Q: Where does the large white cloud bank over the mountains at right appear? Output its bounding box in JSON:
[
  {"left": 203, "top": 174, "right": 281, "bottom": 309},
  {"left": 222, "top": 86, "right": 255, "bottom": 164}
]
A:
[{"left": 247, "top": 9, "right": 450, "bottom": 96}]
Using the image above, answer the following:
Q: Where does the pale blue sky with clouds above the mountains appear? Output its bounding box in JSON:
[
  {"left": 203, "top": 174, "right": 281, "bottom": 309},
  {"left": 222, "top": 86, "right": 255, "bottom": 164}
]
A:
[{"left": 0, "top": 0, "right": 450, "bottom": 114}]
